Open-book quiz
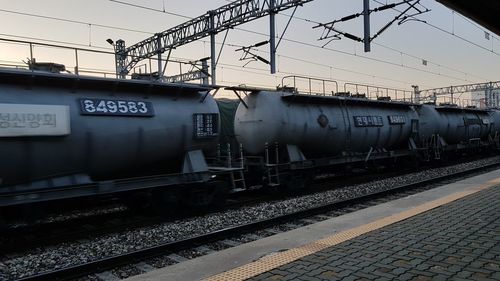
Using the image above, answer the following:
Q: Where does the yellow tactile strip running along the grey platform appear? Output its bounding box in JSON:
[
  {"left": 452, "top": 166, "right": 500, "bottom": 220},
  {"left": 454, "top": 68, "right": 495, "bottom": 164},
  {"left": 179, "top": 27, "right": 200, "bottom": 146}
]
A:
[{"left": 204, "top": 178, "right": 500, "bottom": 281}]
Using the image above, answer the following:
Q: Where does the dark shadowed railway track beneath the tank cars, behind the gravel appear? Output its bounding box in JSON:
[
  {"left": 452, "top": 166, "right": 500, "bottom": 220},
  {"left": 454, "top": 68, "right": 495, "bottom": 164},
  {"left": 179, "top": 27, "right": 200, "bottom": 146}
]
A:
[{"left": 0, "top": 161, "right": 415, "bottom": 254}]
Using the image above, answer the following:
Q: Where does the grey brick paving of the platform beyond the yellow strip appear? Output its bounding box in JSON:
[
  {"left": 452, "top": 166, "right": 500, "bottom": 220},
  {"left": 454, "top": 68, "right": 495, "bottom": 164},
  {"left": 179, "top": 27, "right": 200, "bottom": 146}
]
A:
[{"left": 249, "top": 186, "right": 500, "bottom": 281}]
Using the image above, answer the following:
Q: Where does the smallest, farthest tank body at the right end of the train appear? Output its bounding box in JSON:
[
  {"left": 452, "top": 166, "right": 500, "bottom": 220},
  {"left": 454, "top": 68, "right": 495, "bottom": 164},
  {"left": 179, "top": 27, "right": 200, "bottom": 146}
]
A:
[{"left": 418, "top": 105, "right": 492, "bottom": 144}]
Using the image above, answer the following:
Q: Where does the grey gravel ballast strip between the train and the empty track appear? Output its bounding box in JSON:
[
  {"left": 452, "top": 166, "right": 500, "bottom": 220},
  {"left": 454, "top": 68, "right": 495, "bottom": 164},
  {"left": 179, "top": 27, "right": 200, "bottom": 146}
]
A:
[{"left": 0, "top": 157, "right": 500, "bottom": 280}]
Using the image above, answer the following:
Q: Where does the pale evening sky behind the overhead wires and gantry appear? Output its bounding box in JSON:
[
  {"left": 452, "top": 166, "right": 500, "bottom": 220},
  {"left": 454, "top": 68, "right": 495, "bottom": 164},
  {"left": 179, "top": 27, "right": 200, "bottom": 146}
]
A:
[{"left": 0, "top": 0, "right": 500, "bottom": 97}]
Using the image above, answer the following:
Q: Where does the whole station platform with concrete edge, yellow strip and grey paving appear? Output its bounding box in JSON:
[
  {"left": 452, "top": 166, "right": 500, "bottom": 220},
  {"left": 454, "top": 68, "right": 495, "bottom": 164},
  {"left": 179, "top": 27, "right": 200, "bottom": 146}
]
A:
[{"left": 127, "top": 167, "right": 500, "bottom": 280}]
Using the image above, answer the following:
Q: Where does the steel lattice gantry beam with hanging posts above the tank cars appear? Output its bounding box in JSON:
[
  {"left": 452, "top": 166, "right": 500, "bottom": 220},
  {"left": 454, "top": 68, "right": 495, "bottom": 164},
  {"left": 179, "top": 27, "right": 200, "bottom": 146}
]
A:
[{"left": 115, "top": 0, "right": 313, "bottom": 84}]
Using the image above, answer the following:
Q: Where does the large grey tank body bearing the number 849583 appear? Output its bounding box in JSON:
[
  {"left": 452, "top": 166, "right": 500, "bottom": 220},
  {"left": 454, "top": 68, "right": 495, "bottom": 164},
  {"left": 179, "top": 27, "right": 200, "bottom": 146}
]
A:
[{"left": 0, "top": 68, "right": 218, "bottom": 186}]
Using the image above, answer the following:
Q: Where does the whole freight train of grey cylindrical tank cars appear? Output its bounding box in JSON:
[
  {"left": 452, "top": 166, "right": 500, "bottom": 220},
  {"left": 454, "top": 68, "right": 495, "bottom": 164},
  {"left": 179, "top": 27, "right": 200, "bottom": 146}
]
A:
[{"left": 0, "top": 64, "right": 500, "bottom": 215}]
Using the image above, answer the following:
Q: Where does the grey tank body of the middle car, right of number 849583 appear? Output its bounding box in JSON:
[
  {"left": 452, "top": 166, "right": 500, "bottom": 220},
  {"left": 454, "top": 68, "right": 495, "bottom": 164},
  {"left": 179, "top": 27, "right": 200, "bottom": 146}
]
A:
[{"left": 235, "top": 91, "right": 417, "bottom": 157}]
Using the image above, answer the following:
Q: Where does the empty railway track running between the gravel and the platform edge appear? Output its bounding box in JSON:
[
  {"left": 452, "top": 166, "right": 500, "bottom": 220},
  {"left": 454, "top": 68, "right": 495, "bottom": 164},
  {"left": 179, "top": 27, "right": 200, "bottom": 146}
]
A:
[{"left": 14, "top": 160, "right": 500, "bottom": 280}]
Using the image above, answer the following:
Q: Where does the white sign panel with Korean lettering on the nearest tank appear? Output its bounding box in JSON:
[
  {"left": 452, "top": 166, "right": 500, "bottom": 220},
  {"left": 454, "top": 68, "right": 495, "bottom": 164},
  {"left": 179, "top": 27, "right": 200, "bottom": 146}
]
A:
[{"left": 0, "top": 103, "right": 71, "bottom": 137}]
